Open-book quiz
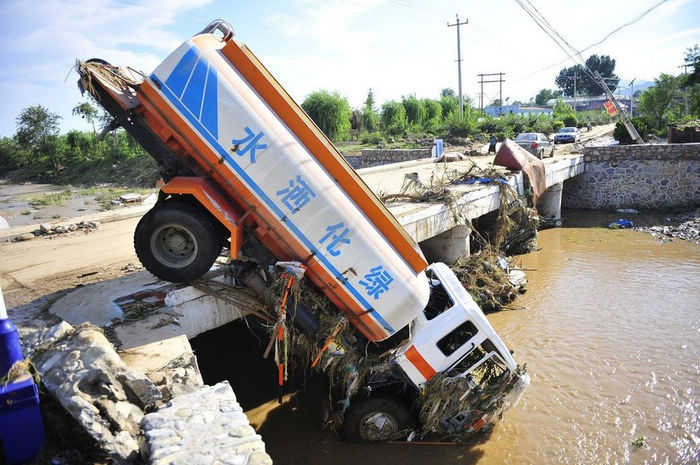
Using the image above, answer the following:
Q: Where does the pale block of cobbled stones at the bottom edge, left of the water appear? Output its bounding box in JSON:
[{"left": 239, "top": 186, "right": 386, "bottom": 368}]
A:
[{"left": 141, "top": 381, "right": 272, "bottom": 465}]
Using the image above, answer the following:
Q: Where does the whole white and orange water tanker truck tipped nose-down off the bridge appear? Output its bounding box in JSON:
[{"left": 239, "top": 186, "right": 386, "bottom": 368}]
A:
[{"left": 77, "top": 20, "right": 529, "bottom": 441}]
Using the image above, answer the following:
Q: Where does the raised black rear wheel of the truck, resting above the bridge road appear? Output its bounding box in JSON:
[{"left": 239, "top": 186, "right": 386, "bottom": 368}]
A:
[{"left": 134, "top": 200, "right": 221, "bottom": 283}]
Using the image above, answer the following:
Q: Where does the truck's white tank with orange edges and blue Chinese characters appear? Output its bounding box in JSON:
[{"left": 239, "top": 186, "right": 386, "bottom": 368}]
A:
[{"left": 80, "top": 20, "right": 430, "bottom": 341}]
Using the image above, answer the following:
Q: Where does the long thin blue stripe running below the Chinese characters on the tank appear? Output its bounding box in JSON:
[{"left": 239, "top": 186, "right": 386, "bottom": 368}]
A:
[{"left": 150, "top": 70, "right": 396, "bottom": 335}]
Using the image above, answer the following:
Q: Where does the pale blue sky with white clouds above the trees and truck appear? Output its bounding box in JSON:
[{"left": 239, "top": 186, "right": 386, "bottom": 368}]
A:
[{"left": 0, "top": 0, "right": 700, "bottom": 137}]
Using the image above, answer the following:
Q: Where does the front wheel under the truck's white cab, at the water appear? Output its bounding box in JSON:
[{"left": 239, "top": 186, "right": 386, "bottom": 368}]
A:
[{"left": 343, "top": 396, "right": 411, "bottom": 442}]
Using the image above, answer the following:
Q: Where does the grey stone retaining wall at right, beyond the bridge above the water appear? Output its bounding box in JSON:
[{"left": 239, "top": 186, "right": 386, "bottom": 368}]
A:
[{"left": 562, "top": 144, "right": 700, "bottom": 209}]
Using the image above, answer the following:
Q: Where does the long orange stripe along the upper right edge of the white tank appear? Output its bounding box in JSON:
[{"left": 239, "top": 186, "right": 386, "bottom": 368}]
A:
[{"left": 216, "top": 36, "right": 428, "bottom": 273}]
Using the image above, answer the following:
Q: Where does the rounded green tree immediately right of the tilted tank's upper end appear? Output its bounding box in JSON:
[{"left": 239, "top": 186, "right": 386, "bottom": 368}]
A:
[{"left": 301, "top": 90, "right": 350, "bottom": 140}]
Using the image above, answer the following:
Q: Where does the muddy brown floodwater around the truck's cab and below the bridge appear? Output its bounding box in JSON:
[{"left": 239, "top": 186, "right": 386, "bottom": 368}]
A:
[{"left": 193, "top": 216, "right": 700, "bottom": 465}]
